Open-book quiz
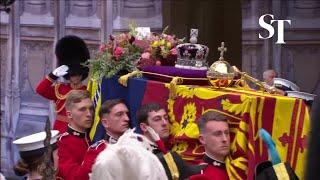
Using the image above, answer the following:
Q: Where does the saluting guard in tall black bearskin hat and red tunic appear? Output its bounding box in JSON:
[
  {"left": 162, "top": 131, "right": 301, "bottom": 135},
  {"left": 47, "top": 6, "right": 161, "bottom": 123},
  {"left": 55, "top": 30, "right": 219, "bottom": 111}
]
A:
[{"left": 36, "top": 36, "right": 90, "bottom": 133}]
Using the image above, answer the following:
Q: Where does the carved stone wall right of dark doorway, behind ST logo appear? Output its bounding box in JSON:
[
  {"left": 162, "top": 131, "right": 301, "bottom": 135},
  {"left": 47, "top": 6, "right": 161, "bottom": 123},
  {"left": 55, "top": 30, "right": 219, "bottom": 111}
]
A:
[{"left": 242, "top": 0, "right": 320, "bottom": 93}]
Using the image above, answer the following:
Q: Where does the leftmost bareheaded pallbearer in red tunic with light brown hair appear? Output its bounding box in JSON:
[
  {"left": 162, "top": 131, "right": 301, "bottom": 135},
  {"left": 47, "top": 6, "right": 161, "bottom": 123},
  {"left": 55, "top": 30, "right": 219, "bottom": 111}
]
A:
[{"left": 57, "top": 90, "right": 93, "bottom": 180}]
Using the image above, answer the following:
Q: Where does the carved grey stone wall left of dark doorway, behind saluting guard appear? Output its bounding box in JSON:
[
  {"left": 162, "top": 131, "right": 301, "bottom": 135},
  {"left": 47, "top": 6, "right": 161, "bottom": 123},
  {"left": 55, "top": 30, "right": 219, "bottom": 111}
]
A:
[{"left": 0, "top": 0, "right": 162, "bottom": 176}]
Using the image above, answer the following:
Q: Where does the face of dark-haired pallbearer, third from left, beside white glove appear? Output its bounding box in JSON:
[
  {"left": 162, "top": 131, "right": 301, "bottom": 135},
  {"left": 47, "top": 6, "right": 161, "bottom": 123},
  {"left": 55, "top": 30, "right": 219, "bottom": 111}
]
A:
[{"left": 147, "top": 109, "right": 170, "bottom": 140}]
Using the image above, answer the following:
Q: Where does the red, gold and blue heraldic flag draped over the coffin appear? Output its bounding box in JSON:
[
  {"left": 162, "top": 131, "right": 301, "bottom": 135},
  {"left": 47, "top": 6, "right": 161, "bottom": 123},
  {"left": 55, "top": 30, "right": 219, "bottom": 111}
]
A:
[{"left": 91, "top": 78, "right": 309, "bottom": 179}]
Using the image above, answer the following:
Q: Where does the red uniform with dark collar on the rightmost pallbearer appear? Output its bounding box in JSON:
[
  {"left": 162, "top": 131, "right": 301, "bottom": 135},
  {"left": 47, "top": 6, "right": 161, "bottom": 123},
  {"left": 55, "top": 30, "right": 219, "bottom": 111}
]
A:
[{"left": 190, "top": 155, "right": 229, "bottom": 180}]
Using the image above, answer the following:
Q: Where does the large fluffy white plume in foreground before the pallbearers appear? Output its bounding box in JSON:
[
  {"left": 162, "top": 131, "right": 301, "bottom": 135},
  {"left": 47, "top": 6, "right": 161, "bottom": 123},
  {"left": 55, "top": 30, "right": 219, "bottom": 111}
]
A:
[{"left": 90, "top": 130, "right": 167, "bottom": 180}]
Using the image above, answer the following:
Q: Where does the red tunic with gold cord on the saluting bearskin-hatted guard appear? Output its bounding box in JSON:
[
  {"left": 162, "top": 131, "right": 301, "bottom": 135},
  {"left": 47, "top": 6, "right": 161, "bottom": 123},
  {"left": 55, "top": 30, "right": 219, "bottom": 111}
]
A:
[{"left": 36, "top": 76, "right": 87, "bottom": 133}]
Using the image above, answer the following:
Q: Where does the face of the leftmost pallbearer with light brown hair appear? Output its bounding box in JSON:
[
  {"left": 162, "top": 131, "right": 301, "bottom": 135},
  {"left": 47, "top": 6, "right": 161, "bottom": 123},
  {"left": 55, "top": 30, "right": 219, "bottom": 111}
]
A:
[{"left": 67, "top": 98, "right": 93, "bottom": 131}]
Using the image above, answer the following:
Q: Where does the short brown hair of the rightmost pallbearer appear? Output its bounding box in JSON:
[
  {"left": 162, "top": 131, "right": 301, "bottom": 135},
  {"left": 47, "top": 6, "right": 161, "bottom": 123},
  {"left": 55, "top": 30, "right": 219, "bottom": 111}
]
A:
[{"left": 199, "top": 111, "right": 228, "bottom": 133}]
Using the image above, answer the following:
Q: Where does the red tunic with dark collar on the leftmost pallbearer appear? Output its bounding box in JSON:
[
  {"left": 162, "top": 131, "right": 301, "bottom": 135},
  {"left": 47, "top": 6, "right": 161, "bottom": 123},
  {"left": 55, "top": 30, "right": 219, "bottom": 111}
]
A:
[{"left": 57, "top": 126, "right": 92, "bottom": 180}]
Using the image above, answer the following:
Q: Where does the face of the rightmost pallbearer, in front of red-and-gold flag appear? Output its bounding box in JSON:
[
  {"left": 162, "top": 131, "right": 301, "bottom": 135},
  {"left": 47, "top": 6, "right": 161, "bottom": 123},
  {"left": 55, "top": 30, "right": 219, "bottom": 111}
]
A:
[{"left": 199, "top": 121, "right": 230, "bottom": 161}]
